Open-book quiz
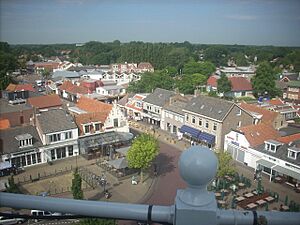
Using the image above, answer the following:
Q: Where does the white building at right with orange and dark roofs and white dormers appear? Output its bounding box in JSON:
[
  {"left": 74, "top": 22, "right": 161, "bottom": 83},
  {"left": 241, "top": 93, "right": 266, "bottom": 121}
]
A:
[{"left": 224, "top": 124, "right": 300, "bottom": 185}]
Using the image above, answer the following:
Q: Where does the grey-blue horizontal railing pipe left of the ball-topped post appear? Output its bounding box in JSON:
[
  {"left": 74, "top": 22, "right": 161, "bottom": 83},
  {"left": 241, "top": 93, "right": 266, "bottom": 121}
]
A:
[{"left": 0, "top": 192, "right": 174, "bottom": 224}]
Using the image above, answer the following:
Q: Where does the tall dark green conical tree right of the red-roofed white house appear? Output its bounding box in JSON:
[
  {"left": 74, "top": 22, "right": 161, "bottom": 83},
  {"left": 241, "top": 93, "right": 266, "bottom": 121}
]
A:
[{"left": 251, "top": 62, "right": 278, "bottom": 98}]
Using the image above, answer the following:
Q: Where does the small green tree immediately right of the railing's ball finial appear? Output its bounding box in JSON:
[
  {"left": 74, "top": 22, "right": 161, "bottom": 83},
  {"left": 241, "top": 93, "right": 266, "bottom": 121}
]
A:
[{"left": 217, "top": 152, "right": 235, "bottom": 178}]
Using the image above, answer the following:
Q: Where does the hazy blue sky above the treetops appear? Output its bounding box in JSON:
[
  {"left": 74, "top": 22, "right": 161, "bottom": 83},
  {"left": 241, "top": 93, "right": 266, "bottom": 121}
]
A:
[{"left": 0, "top": 0, "right": 300, "bottom": 46}]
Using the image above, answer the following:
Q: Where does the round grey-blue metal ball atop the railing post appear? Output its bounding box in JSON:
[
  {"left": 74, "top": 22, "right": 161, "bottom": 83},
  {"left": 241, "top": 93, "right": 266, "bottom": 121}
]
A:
[{"left": 179, "top": 146, "right": 218, "bottom": 187}]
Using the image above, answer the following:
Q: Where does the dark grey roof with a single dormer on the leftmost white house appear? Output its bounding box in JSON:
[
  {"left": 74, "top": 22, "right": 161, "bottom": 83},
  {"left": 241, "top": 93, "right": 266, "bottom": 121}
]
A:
[{"left": 0, "top": 125, "right": 43, "bottom": 154}]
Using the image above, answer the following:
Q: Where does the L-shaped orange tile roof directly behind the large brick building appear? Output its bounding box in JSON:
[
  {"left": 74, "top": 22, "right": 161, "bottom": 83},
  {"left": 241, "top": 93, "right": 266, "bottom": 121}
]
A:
[{"left": 240, "top": 102, "right": 279, "bottom": 124}]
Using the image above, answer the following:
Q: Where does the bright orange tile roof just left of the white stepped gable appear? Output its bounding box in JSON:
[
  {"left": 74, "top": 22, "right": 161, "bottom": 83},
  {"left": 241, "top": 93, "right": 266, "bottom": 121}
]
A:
[{"left": 76, "top": 97, "right": 112, "bottom": 113}]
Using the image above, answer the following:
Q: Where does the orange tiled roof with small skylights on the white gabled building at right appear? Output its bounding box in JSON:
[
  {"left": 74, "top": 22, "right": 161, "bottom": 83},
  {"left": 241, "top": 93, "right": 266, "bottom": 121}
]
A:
[{"left": 239, "top": 123, "right": 280, "bottom": 147}]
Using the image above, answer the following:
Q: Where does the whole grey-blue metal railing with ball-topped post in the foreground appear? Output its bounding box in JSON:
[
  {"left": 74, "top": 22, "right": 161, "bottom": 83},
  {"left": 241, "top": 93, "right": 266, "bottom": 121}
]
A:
[{"left": 0, "top": 146, "right": 300, "bottom": 225}]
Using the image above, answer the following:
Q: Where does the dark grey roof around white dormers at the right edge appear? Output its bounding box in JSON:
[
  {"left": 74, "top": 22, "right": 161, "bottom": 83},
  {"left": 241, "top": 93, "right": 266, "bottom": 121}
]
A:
[{"left": 255, "top": 140, "right": 300, "bottom": 166}]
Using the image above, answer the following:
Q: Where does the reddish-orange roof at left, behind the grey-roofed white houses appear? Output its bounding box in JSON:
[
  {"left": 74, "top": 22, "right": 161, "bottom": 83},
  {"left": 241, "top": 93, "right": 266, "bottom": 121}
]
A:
[{"left": 27, "top": 95, "right": 62, "bottom": 109}]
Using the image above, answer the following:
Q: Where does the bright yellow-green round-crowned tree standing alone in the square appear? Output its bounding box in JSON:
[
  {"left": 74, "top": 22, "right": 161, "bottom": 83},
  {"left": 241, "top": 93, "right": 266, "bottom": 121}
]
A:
[{"left": 127, "top": 134, "right": 159, "bottom": 182}]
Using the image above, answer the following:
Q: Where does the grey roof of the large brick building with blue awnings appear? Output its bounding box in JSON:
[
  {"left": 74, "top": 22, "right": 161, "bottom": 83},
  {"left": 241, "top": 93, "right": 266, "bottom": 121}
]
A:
[{"left": 184, "top": 95, "right": 234, "bottom": 121}]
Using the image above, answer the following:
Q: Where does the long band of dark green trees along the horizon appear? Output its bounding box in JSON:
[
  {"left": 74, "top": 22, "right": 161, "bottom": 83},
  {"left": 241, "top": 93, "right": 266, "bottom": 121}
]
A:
[{"left": 8, "top": 40, "right": 300, "bottom": 71}]
